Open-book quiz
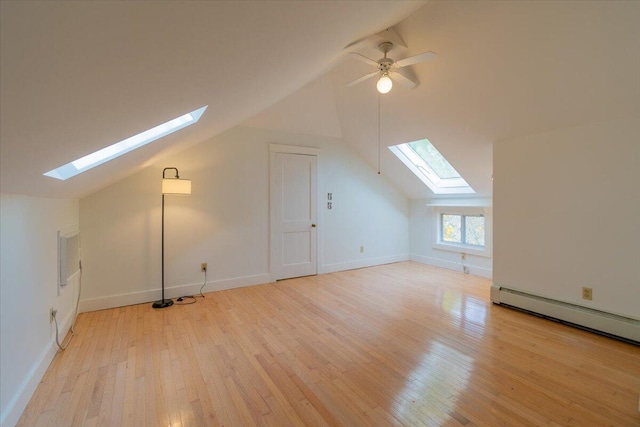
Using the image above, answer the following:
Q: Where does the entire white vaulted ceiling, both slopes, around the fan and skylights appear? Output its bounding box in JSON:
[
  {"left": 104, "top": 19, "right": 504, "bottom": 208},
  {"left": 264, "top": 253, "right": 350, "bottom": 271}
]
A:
[{"left": 0, "top": 1, "right": 640, "bottom": 198}]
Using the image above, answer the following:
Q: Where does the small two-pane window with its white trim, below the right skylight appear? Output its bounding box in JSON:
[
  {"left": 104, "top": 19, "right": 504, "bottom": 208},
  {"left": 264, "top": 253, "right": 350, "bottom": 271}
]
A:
[{"left": 432, "top": 206, "right": 491, "bottom": 257}]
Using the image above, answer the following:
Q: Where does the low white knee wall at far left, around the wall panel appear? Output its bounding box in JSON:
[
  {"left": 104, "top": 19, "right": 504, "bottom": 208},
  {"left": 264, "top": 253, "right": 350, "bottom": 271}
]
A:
[{"left": 0, "top": 194, "right": 79, "bottom": 425}]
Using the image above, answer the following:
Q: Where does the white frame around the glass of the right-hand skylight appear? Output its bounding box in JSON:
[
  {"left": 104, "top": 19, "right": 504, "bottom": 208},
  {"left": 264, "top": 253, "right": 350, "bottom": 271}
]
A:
[{"left": 389, "top": 138, "right": 475, "bottom": 194}]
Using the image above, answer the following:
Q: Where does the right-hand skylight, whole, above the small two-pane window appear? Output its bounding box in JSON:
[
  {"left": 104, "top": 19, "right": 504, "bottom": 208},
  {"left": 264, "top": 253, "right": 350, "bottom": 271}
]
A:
[{"left": 389, "top": 139, "right": 475, "bottom": 194}]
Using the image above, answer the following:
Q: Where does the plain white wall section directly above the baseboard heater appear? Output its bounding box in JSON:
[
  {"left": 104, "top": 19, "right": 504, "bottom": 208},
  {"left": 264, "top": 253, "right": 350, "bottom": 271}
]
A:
[{"left": 494, "top": 117, "right": 640, "bottom": 319}]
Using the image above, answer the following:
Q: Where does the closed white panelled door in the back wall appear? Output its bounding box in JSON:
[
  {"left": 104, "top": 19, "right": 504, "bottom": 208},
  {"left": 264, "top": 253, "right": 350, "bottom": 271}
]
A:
[{"left": 271, "top": 152, "right": 317, "bottom": 280}]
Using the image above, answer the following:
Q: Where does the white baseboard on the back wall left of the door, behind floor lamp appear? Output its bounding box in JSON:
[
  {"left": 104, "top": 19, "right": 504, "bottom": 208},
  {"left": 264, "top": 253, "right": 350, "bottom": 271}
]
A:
[{"left": 80, "top": 274, "right": 270, "bottom": 313}]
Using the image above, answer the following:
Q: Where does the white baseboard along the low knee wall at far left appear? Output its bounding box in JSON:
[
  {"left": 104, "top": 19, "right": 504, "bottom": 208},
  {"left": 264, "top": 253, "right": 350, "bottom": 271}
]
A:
[{"left": 0, "top": 311, "right": 73, "bottom": 426}]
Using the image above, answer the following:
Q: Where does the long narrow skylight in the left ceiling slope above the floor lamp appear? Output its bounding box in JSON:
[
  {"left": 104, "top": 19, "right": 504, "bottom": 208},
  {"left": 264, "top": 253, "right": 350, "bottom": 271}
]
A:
[{"left": 43, "top": 105, "right": 208, "bottom": 181}]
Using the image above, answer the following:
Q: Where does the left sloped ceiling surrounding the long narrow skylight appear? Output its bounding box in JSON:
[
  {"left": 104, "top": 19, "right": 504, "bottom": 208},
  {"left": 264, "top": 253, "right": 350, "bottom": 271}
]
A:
[{"left": 0, "top": 0, "right": 423, "bottom": 197}]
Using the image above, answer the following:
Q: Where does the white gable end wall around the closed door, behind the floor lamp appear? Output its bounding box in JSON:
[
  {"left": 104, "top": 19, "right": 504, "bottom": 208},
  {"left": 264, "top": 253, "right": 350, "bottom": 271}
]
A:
[{"left": 80, "top": 127, "right": 409, "bottom": 310}]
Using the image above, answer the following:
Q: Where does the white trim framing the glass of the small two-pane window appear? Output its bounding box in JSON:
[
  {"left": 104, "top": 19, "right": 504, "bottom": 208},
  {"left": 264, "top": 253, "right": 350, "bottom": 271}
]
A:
[{"left": 432, "top": 206, "right": 493, "bottom": 258}]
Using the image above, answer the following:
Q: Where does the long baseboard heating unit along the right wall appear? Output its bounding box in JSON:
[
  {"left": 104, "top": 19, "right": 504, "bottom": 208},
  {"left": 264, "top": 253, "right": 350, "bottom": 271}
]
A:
[{"left": 491, "top": 285, "right": 640, "bottom": 345}]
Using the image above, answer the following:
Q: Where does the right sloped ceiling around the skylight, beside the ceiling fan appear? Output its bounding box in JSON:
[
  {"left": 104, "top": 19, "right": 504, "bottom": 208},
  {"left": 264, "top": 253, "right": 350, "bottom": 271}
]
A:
[{"left": 247, "top": 1, "right": 640, "bottom": 198}]
